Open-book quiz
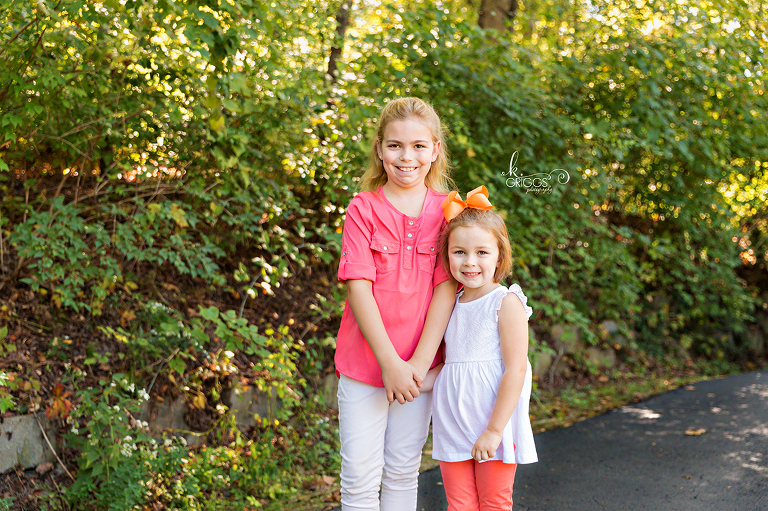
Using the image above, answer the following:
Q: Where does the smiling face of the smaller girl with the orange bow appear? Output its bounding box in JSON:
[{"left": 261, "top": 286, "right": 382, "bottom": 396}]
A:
[{"left": 448, "top": 225, "right": 499, "bottom": 301}]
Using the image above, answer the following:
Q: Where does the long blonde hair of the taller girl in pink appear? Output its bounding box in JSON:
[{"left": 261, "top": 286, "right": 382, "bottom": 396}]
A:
[{"left": 360, "top": 97, "right": 453, "bottom": 193}]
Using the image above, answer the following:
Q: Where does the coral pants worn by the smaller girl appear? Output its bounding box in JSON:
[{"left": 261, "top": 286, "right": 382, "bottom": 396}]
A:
[{"left": 440, "top": 460, "right": 517, "bottom": 511}]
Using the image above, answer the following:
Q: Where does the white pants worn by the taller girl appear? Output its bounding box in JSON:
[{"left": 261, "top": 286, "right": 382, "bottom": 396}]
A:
[{"left": 338, "top": 375, "right": 432, "bottom": 511}]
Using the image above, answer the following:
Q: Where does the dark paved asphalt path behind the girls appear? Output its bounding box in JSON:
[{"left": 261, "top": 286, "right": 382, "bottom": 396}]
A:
[{"left": 332, "top": 371, "right": 768, "bottom": 511}]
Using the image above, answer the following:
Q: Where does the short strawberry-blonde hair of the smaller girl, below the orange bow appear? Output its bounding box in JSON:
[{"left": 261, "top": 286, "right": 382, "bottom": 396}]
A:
[{"left": 439, "top": 208, "right": 512, "bottom": 284}]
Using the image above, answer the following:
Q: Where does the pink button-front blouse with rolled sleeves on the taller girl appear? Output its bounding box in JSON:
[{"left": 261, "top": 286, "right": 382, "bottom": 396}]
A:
[{"left": 335, "top": 188, "right": 449, "bottom": 387}]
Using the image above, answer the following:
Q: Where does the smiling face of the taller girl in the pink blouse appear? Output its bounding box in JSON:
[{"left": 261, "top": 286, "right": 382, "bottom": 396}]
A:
[{"left": 378, "top": 119, "right": 440, "bottom": 193}]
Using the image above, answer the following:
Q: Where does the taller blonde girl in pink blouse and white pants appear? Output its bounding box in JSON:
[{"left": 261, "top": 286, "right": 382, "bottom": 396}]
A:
[{"left": 335, "top": 98, "right": 456, "bottom": 511}]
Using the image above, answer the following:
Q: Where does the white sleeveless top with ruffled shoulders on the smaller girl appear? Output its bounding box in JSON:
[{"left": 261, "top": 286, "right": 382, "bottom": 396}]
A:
[{"left": 432, "top": 284, "right": 538, "bottom": 463}]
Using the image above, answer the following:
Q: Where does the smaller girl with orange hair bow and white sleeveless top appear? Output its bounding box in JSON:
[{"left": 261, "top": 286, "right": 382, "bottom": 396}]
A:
[{"left": 432, "top": 186, "right": 537, "bottom": 511}]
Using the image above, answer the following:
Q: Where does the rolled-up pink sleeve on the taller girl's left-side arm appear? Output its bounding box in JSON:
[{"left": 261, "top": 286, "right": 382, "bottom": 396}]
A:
[{"left": 339, "top": 199, "right": 376, "bottom": 282}]
